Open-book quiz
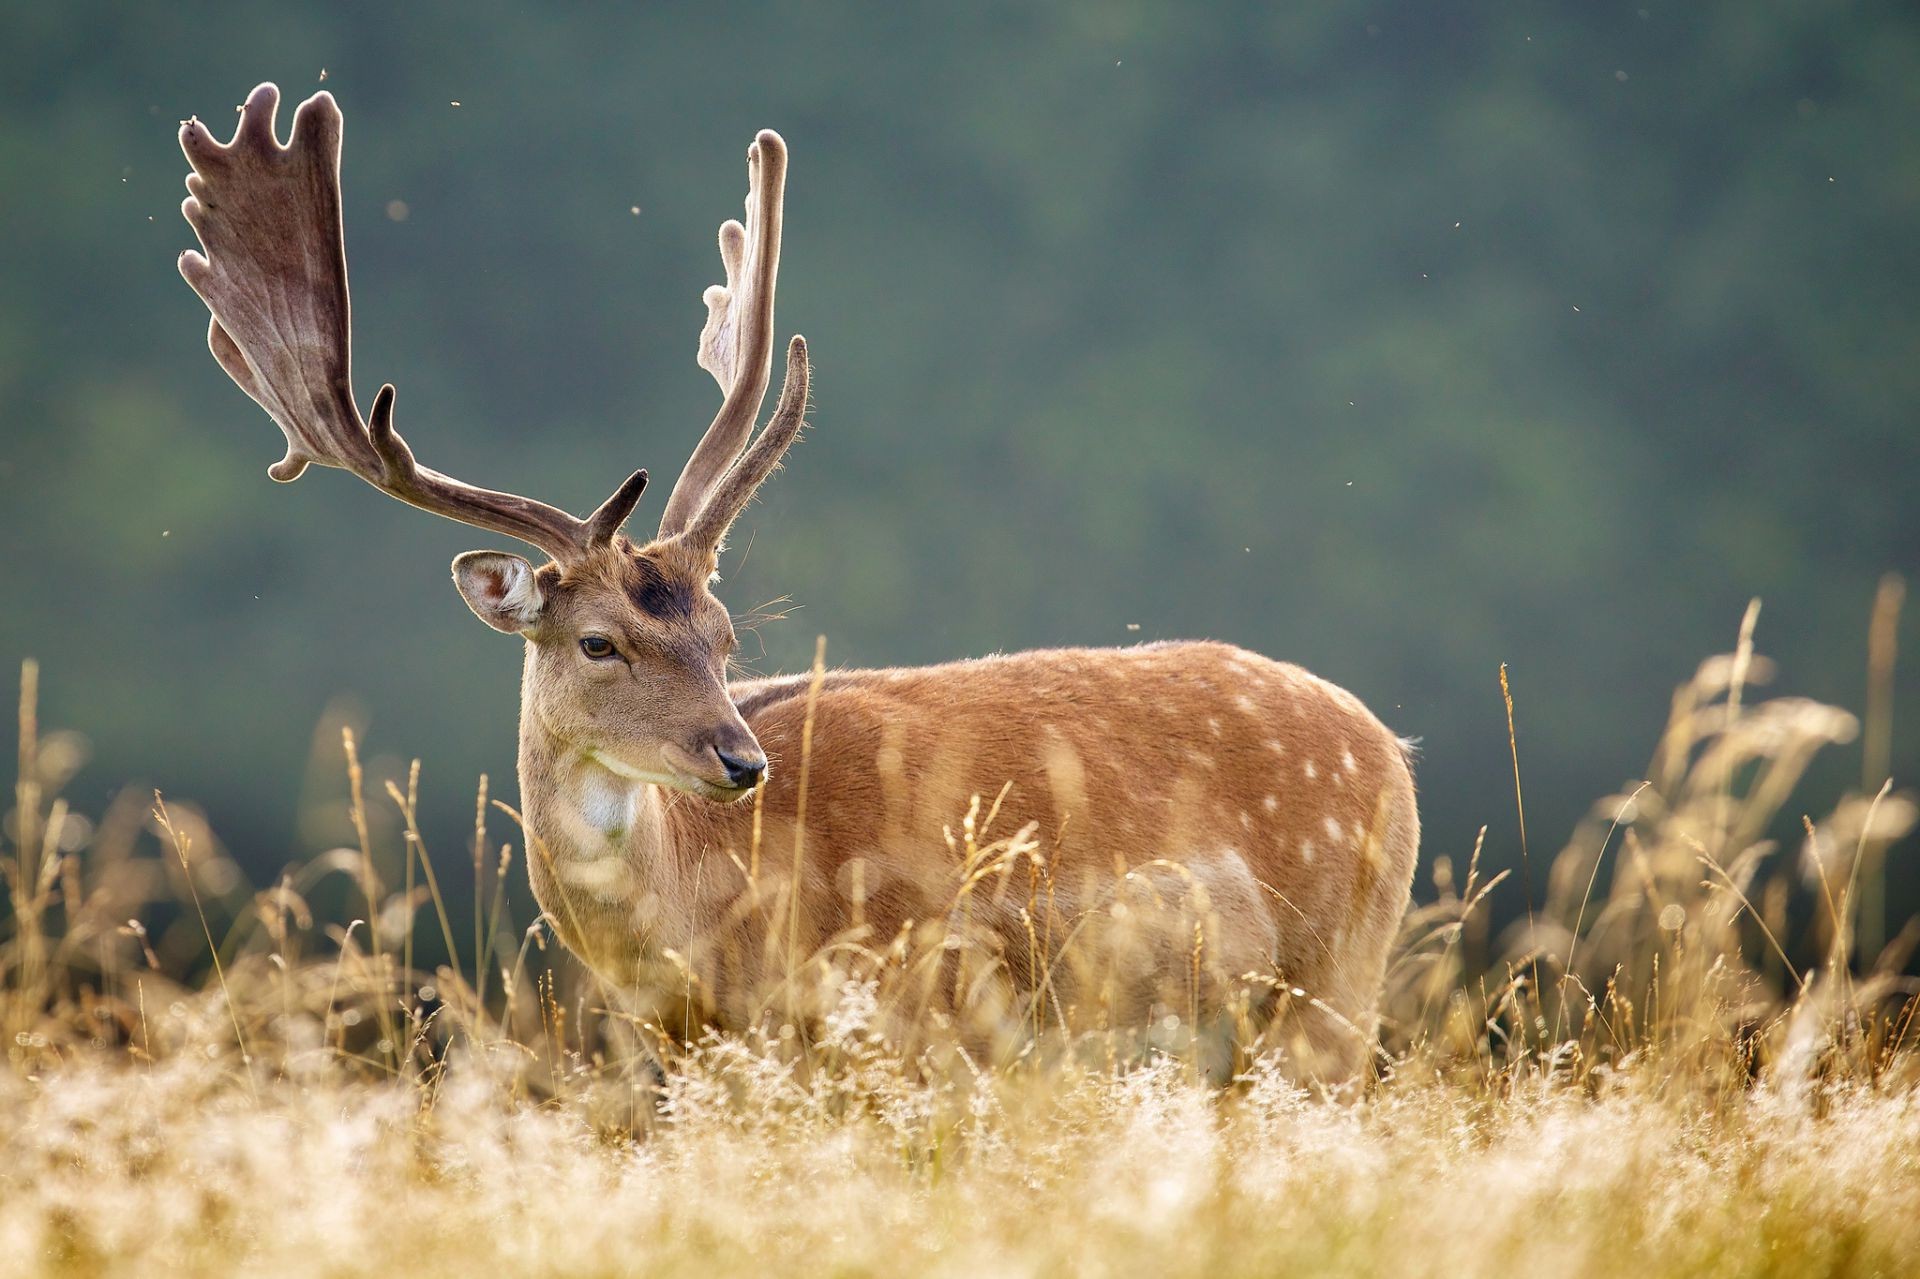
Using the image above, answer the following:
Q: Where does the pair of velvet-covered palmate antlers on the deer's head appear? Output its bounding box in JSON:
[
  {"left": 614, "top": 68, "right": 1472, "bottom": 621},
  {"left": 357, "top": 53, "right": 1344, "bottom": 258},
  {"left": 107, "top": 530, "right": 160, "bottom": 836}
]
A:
[{"left": 180, "top": 84, "right": 806, "bottom": 563}]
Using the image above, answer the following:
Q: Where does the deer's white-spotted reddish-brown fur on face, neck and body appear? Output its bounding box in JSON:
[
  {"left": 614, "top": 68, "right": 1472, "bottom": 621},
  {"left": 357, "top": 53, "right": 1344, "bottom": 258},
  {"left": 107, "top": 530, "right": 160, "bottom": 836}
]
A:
[{"left": 503, "top": 540, "right": 1419, "bottom": 1077}]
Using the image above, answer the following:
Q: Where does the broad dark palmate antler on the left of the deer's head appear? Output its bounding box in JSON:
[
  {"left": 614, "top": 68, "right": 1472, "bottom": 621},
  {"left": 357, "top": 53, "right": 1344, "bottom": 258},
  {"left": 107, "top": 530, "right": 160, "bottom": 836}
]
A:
[{"left": 180, "top": 84, "right": 629, "bottom": 559}]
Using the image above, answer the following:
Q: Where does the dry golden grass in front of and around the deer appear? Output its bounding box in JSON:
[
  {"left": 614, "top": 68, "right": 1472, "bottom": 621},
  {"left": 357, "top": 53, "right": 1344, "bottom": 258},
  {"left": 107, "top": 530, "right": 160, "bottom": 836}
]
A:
[{"left": 0, "top": 615, "right": 1920, "bottom": 1275}]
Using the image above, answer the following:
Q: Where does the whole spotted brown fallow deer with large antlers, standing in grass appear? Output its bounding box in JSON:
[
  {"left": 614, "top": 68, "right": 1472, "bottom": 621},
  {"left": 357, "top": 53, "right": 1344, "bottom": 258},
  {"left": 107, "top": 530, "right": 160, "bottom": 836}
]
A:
[{"left": 179, "top": 83, "right": 1419, "bottom": 1083}]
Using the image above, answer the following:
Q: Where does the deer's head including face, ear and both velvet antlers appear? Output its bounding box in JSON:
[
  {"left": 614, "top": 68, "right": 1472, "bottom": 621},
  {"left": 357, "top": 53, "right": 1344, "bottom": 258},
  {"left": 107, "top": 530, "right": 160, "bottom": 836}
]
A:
[{"left": 180, "top": 84, "right": 806, "bottom": 799}]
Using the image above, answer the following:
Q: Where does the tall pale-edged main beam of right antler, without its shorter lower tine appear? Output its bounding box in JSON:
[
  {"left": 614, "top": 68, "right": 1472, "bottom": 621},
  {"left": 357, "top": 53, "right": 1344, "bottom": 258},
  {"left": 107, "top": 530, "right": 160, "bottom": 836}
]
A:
[{"left": 660, "top": 129, "right": 787, "bottom": 538}]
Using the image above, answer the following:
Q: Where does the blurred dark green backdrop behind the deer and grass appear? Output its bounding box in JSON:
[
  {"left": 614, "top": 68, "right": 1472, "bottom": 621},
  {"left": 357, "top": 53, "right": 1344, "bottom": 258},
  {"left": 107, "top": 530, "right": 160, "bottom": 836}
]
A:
[{"left": 0, "top": 0, "right": 1920, "bottom": 925}]
